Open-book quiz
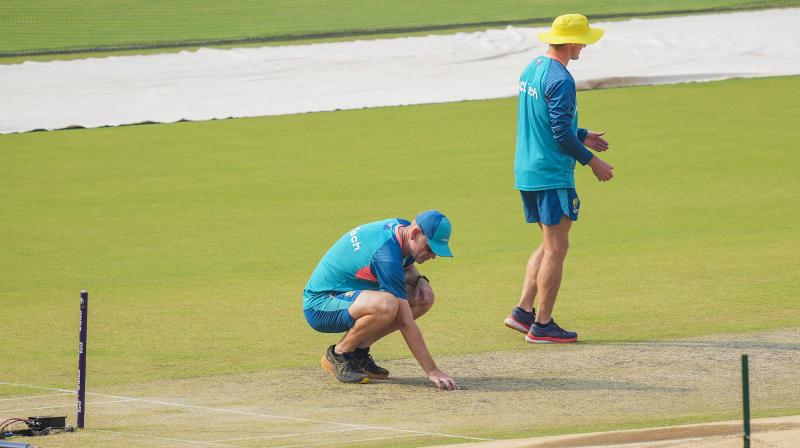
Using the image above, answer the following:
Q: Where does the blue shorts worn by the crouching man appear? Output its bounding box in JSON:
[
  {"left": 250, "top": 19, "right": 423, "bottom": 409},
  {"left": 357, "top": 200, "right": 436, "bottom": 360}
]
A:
[{"left": 303, "top": 291, "right": 361, "bottom": 333}]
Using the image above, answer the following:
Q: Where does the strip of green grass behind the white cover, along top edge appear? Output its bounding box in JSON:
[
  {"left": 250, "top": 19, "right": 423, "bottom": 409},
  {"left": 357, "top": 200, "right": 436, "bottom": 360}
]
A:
[{"left": 0, "top": 0, "right": 800, "bottom": 55}]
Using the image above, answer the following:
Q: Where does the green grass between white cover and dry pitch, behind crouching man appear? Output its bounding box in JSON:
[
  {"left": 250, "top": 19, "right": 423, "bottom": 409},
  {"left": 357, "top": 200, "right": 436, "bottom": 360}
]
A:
[{"left": 0, "top": 77, "right": 800, "bottom": 394}]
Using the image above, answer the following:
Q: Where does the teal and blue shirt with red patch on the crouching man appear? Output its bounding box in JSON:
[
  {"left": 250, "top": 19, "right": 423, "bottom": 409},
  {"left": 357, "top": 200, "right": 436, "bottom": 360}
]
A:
[{"left": 303, "top": 218, "right": 414, "bottom": 308}]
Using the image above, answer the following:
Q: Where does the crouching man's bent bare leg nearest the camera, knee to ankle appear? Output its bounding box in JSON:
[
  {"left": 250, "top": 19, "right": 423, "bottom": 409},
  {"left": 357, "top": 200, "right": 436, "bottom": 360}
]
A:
[{"left": 334, "top": 291, "right": 398, "bottom": 354}]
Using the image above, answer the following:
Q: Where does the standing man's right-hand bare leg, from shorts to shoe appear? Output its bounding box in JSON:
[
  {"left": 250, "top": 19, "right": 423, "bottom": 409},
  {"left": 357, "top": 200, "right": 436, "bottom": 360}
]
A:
[{"left": 536, "top": 216, "right": 572, "bottom": 324}]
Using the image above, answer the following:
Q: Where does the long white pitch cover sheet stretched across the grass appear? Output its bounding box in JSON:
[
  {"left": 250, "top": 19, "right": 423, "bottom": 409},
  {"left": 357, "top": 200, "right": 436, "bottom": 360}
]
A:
[{"left": 0, "top": 8, "right": 800, "bottom": 134}]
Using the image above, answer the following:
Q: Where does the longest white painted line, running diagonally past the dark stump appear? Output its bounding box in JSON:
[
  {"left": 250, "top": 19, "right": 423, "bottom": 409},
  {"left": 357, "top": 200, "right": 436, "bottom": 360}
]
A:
[{"left": 0, "top": 381, "right": 492, "bottom": 441}]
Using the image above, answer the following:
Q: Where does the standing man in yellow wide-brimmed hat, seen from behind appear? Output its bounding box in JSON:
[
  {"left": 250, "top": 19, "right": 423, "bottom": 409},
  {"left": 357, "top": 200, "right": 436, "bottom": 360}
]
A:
[{"left": 505, "top": 14, "right": 614, "bottom": 343}]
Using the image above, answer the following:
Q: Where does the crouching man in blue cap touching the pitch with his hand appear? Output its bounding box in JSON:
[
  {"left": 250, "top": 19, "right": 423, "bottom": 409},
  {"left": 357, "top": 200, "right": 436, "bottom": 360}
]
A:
[{"left": 303, "top": 210, "right": 459, "bottom": 390}]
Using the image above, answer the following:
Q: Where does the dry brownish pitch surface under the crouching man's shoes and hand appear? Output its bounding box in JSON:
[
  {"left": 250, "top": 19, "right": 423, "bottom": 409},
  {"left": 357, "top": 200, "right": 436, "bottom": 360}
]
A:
[{"left": 0, "top": 328, "right": 800, "bottom": 448}]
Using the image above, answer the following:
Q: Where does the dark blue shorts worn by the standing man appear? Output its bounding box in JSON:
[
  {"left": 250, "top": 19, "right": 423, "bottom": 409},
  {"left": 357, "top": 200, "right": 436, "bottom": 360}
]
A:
[{"left": 520, "top": 188, "right": 581, "bottom": 226}]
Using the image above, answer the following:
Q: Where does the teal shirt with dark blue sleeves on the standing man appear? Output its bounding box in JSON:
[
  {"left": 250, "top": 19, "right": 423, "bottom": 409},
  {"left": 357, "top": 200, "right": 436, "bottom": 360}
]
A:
[{"left": 514, "top": 56, "right": 592, "bottom": 191}]
